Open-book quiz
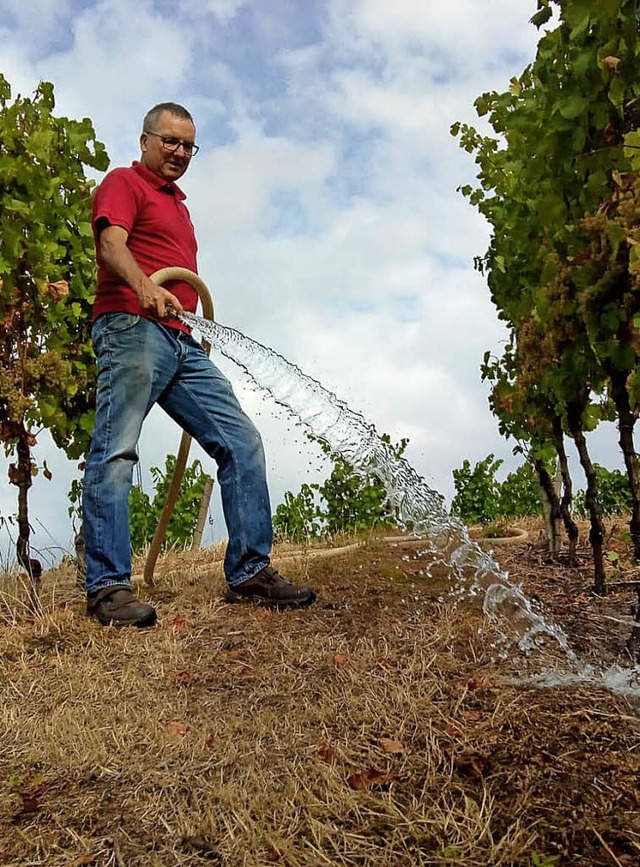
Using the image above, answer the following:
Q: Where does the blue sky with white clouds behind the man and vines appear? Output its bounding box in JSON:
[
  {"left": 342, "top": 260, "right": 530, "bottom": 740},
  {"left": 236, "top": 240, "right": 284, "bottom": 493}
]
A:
[{"left": 0, "top": 0, "right": 620, "bottom": 566}]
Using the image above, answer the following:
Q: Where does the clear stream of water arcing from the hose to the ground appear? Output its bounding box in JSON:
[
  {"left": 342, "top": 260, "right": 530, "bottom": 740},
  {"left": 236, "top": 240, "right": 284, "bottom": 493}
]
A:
[{"left": 179, "top": 312, "right": 640, "bottom": 694}]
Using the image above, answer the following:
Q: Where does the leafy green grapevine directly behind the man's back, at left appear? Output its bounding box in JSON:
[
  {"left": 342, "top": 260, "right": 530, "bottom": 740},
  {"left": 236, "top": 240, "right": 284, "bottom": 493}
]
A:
[{"left": 0, "top": 75, "right": 109, "bottom": 572}]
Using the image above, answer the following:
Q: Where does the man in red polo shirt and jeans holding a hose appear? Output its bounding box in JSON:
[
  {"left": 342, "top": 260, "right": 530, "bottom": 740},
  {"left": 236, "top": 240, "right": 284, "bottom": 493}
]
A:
[{"left": 83, "top": 103, "right": 315, "bottom": 626}]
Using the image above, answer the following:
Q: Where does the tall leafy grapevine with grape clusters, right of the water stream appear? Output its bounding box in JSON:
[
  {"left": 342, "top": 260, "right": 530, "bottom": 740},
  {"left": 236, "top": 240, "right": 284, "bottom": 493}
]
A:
[{"left": 452, "top": 0, "right": 640, "bottom": 592}]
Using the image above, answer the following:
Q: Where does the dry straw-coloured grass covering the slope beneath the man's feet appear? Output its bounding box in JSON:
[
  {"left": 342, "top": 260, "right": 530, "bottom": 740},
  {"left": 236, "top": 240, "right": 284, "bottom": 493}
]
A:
[{"left": 0, "top": 541, "right": 640, "bottom": 867}]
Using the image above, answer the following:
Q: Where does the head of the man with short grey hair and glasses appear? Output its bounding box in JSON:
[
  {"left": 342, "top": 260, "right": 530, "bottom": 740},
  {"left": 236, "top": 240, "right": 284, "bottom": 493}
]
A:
[{"left": 140, "top": 102, "right": 197, "bottom": 181}]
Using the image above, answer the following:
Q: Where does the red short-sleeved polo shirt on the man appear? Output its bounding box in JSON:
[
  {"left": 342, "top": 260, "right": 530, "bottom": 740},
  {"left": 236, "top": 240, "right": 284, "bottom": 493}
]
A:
[{"left": 93, "top": 162, "right": 198, "bottom": 331}]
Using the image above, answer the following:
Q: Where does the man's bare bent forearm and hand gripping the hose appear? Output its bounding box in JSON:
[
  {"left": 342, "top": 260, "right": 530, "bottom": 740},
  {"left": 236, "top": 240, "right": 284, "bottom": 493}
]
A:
[{"left": 98, "top": 225, "right": 183, "bottom": 319}]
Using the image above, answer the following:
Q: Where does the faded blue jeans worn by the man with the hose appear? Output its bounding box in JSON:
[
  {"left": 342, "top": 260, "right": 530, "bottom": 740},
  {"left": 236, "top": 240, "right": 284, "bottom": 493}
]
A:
[{"left": 82, "top": 313, "right": 272, "bottom": 593}]
